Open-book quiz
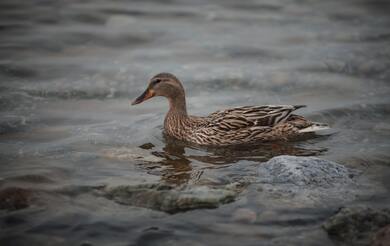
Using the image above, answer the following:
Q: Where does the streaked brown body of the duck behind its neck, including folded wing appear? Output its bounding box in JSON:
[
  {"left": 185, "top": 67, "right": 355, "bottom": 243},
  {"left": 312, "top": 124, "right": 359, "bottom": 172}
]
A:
[{"left": 187, "top": 105, "right": 324, "bottom": 145}]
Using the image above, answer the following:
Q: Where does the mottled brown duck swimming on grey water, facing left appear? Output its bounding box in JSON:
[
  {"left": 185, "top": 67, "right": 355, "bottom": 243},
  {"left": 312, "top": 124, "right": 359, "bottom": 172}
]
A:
[{"left": 131, "top": 73, "right": 329, "bottom": 146}]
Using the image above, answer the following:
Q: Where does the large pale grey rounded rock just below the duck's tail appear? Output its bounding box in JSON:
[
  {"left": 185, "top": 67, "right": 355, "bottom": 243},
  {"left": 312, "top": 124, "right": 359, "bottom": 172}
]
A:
[{"left": 256, "top": 155, "right": 368, "bottom": 207}]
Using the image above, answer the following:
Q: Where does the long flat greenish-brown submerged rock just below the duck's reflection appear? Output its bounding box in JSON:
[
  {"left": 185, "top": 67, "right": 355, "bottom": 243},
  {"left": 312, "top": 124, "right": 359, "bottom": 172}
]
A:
[{"left": 105, "top": 184, "right": 239, "bottom": 213}]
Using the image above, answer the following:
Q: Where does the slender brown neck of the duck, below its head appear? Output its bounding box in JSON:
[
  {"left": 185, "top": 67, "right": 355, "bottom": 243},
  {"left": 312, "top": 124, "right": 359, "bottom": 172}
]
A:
[{"left": 164, "top": 95, "right": 189, "bottom": 137}]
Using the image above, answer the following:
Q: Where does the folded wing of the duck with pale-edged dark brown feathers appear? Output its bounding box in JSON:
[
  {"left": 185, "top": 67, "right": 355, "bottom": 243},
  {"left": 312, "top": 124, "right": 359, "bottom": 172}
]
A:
[{"left": 207, "top": 105, "right": 305, "bottom": 131}]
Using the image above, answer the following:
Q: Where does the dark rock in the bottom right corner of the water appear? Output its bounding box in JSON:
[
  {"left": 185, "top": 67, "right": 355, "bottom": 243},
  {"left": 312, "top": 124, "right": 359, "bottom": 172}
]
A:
[{"left": 323, "top": 207, "right": 390, "bottom": 246}]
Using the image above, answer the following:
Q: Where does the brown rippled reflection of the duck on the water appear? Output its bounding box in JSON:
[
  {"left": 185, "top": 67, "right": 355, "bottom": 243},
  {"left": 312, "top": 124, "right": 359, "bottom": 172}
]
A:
[{"left": 144, "top": 135, "right": 326, "bottom": 185}]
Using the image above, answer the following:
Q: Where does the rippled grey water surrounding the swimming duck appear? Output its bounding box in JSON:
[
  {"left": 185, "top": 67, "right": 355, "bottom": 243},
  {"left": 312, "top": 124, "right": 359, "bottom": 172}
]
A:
[{"left": 0, "top": 0, "right": 390, "bottom": 245}]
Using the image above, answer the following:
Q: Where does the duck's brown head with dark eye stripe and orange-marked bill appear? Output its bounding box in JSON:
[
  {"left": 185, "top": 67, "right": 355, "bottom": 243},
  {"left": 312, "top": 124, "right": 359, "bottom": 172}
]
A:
[{"left": 131, "top": 73, "right": 184, "bottom": 105}]
